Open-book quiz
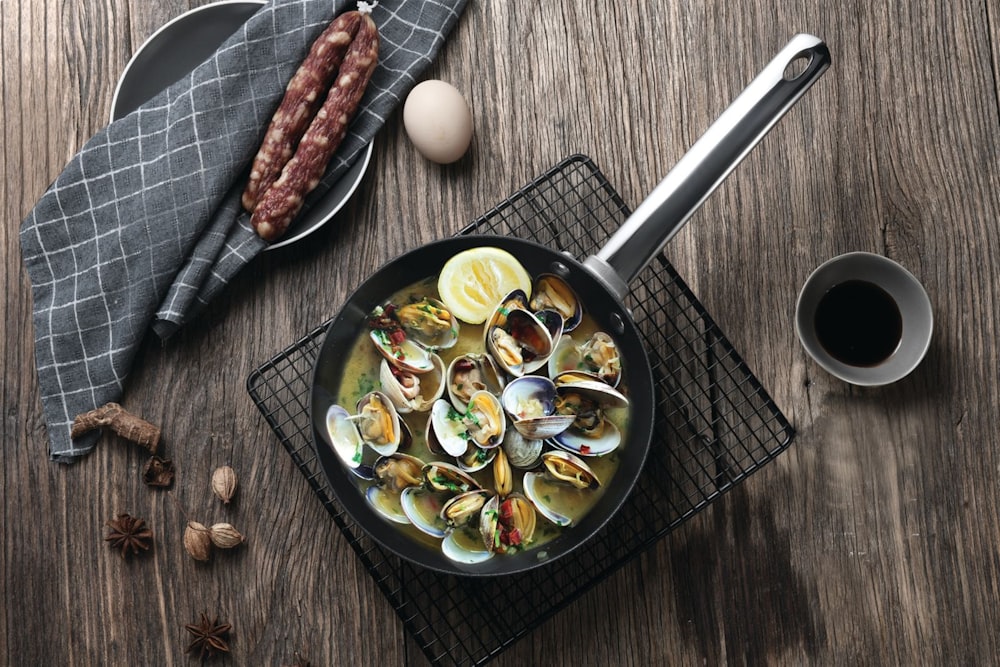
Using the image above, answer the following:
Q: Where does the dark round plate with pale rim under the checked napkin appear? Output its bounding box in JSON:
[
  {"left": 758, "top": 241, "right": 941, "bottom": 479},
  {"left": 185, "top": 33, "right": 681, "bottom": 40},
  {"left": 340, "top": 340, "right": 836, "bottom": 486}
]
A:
[{"left": 111, "top": 0, "right": 372, "bottom": 250}]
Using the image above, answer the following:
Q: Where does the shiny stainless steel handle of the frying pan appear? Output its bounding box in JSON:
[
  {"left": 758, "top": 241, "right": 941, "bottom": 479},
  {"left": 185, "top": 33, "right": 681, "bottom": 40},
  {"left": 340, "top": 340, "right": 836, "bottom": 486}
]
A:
[{"left": 584, "top": 34, "right": 830, "bottom": 298}]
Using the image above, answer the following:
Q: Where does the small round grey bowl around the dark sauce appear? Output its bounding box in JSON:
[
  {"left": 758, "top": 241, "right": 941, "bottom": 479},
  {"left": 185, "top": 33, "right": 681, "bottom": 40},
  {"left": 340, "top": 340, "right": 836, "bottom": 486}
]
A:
[{"left": 795, "top": 252, "right": 934, "bottom": 387}]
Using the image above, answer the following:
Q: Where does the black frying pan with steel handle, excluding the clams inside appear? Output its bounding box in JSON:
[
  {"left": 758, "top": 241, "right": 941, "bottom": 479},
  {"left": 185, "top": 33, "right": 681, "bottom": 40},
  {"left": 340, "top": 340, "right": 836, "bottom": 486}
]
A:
[{"left": 311, "top": 35, "right": 830, "bottom": 575}]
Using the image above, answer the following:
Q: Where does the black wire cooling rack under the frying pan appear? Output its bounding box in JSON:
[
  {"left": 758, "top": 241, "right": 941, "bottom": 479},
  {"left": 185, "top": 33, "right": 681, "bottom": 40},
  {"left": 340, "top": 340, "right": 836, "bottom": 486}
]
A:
[{"left": 247, "top": 155, "right": 794, "bottom": 665}]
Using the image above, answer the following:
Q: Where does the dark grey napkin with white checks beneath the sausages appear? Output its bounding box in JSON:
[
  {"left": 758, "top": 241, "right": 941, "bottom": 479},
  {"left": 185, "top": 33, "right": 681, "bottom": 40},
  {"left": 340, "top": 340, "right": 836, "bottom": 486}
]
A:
[{"left": 21, "top": 0, "right": 466, "bottom": 462}]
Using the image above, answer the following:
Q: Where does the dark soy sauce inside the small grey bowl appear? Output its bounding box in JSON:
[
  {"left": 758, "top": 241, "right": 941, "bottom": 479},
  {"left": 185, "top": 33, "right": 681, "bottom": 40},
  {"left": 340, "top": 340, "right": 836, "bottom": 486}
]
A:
[{"left": 815, "top": 280, "right": 903, "bottom": 366}]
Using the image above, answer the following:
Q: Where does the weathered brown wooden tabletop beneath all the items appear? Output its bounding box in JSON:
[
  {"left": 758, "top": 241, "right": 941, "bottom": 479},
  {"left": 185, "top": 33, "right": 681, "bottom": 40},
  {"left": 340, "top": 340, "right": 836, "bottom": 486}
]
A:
[{"left": 0, "top": 0, "right": 1000, "bottom": 665}]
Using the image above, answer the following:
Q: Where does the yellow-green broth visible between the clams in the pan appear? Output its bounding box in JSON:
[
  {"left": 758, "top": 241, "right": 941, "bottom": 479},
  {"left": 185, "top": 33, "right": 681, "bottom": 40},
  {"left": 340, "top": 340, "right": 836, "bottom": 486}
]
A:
[{"left": 334, "top": 277, "right": 628, "bottom": 549}]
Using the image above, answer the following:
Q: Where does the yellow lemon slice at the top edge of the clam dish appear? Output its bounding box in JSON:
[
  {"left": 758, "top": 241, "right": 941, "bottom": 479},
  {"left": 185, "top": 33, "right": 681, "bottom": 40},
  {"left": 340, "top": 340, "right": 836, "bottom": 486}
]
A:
[{"left": 438, "top": 247, "right": 531, "bottom": 324}]
